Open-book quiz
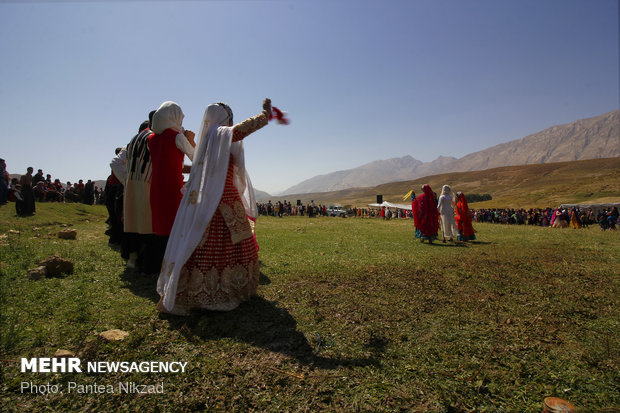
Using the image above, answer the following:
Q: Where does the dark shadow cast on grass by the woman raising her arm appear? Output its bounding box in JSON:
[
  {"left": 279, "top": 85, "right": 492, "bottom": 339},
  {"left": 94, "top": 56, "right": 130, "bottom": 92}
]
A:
[{"left": 160, "top": 296, "right": 380, "bottom": 369}]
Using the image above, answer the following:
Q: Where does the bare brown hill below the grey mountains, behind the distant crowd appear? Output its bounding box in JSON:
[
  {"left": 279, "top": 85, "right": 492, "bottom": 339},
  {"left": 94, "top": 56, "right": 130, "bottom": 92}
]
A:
[{"left": 272, "top": 157, "right": 620, "bottom": 208}]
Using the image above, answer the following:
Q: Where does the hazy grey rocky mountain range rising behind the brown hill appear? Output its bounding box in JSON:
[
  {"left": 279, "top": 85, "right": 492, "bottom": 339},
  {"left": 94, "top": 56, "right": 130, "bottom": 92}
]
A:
[{"left": 280, "top": 110, "right": 620, "bottom": 198}]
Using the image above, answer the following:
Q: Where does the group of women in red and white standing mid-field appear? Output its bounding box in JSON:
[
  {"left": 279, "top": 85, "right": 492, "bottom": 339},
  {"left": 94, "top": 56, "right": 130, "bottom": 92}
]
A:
[{"left": 411, "top": 184, "right": 476, "bottom": 244}]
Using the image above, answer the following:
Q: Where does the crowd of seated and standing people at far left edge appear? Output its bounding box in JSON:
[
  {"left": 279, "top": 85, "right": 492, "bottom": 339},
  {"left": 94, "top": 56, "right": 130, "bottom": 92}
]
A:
[{"left": 0, "top": 159, "right": 104, "bottom": 217}]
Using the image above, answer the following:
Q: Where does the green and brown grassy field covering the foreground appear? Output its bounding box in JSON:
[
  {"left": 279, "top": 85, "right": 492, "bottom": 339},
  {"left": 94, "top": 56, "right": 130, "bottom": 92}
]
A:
[{"left": 0, "top": 204, "right": 620, "bottom": 412}]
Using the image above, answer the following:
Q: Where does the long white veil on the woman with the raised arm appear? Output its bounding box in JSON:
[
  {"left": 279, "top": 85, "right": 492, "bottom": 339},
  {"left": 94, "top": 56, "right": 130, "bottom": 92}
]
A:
[{"left": 157, "top": 104, "right": 258, "bottom": 311}]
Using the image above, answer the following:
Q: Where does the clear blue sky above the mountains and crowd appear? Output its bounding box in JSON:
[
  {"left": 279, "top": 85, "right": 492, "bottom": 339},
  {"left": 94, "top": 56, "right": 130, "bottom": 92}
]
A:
[{"left": 0, "top": 0, "right": 619, "bottom": 193}]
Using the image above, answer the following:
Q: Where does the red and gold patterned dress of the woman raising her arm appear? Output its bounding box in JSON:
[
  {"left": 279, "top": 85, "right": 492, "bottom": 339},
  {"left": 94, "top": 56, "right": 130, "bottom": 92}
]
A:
[{"left": 170, "top": 113, "right": 268, "bottom": 311}]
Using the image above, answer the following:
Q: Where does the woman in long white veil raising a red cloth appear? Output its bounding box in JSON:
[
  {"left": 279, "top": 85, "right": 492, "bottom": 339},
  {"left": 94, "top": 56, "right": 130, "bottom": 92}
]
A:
[{"left": 157, "top": 99, "right": 271, "bottom": 315}]
